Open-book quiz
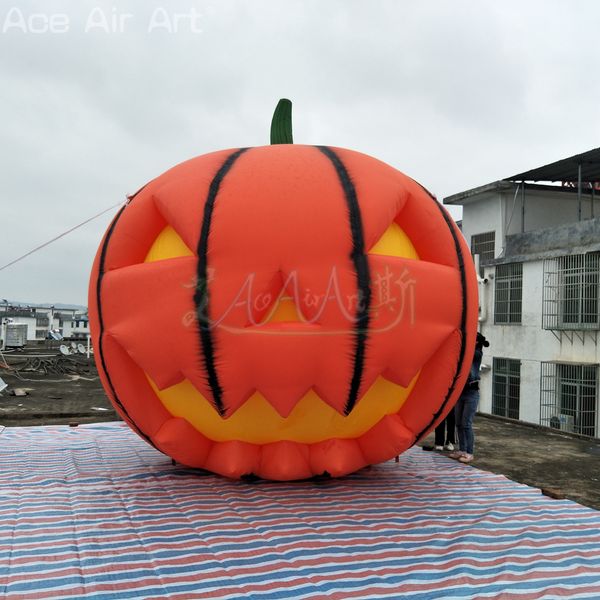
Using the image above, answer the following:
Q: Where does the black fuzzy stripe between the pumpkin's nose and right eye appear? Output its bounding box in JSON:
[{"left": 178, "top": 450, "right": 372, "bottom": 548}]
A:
[{"left": 317, "top": 146, "right": 371, "bottom": 415}]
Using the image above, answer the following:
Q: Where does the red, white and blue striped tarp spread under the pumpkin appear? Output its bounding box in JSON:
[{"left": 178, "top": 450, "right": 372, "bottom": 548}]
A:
[{"left": 0, "top": 423, "right": 600, "bottom": 599}]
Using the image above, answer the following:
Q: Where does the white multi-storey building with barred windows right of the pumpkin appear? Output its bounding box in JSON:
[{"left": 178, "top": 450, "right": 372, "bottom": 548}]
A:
[{"left": 444, "top": 149, "right": 600, "bottom": 437}]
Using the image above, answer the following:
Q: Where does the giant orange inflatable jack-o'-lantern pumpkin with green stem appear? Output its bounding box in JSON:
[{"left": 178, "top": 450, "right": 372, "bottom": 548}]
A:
[{"left": 89, "top": 101, "right": 477, "bottom": 480}]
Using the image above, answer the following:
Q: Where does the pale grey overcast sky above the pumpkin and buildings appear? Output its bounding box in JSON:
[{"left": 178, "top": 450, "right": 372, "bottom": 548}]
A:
[{"left": 0, "top": 0, "right": 600, "bottom": 304}]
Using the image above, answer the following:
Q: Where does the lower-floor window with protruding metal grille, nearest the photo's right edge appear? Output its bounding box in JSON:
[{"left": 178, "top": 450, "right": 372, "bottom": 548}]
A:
[{"left": 540, "top": 362, "right": 598, "bottom": 437}]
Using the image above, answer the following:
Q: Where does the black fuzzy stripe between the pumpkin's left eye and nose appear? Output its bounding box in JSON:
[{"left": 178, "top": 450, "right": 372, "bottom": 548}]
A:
[{"left": 194, "top": 148, "right": 248, "bottom": 416}]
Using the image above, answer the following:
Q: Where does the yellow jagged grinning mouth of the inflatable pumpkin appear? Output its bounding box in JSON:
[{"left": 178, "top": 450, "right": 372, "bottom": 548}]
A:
[{"left": 146, "top": 374, "right": 419, "bottom": 444}]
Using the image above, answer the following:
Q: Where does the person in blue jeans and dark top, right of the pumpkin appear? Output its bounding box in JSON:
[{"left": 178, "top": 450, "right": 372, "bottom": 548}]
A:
[{"left": 448, "top": 332, "right": 490, "bottom": 463}]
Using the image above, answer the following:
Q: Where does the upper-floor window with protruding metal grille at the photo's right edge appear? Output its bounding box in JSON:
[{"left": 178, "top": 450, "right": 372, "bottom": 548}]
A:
[{"left": 542, "top": 252, "right": 600, "bottom": 331}]
